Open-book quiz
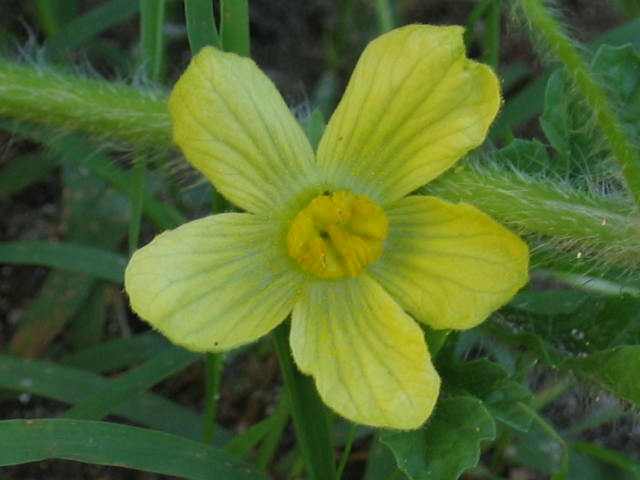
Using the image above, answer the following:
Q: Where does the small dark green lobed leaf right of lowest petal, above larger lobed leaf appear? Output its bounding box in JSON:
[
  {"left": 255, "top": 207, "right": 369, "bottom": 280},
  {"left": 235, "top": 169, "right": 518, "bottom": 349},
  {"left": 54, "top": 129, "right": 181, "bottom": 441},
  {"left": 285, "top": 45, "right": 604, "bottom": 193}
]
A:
[{"left": 437, "top": 356, "right": 533, "bottom": 431}]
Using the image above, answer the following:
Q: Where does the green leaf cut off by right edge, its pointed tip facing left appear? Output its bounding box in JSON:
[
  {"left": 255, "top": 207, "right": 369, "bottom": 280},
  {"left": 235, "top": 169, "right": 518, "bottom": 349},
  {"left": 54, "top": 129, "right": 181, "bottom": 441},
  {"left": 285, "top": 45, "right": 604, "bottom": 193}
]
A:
[{"left": 566, "top": 345, "right": 640, "bottom": 404}]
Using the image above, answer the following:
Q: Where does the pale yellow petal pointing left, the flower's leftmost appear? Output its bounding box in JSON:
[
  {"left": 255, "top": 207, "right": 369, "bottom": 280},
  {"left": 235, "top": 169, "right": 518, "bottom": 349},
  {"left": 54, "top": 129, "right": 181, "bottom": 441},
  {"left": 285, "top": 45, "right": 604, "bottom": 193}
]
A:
[{"left": 125, "top": 213, "right": 301, "bottom": 351}]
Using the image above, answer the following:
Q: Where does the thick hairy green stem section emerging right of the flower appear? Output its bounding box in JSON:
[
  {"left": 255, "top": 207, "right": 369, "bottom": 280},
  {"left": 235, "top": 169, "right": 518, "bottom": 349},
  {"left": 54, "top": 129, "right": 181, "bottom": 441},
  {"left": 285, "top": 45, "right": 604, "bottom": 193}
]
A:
[{"left": 425, "top": 166, "right": 640, "bottom": 268}]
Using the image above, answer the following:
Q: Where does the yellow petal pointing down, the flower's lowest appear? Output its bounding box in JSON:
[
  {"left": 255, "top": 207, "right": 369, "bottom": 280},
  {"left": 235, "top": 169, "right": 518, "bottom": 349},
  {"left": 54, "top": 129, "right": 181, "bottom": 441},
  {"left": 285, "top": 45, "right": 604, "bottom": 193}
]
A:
[{"left": 291, "top": 275, "right": 440, "bottom": 429}]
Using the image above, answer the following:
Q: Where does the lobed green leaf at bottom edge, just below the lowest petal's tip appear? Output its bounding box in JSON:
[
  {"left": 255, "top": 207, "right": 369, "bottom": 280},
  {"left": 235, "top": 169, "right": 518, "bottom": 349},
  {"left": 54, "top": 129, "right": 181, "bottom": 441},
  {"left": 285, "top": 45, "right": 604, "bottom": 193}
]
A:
[{"left": 381, "top": 397, "right": 496, "bottom": 480}]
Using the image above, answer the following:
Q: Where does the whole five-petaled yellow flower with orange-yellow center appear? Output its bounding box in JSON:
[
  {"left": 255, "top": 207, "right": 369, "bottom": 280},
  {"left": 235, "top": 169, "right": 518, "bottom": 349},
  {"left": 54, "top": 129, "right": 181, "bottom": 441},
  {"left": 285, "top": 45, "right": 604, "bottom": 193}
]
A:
[{"left": 125, "top": 25, "right": 528, "bottom": 429}]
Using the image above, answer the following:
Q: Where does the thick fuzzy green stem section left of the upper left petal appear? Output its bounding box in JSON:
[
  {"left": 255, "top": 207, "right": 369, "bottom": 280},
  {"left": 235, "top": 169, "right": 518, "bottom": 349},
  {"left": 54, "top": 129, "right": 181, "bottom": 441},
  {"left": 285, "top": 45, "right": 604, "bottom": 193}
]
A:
[{"left": 0, "top": 59, "right": 171, "bottom": 148}]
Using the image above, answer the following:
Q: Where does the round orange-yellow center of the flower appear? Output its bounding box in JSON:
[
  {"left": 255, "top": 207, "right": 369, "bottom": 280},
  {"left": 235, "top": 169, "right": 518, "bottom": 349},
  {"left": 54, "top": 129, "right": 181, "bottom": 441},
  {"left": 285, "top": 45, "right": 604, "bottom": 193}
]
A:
[{"left": 287, "top": 192, "right": 389, "bottom": 278}]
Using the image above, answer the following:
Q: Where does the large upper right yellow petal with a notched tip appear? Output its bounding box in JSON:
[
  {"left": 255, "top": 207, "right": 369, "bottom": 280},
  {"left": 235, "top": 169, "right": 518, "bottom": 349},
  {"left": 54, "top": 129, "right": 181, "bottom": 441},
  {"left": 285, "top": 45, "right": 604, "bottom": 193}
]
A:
[{"left": 318, "top": 25, "right": 500, "bottom": 205}]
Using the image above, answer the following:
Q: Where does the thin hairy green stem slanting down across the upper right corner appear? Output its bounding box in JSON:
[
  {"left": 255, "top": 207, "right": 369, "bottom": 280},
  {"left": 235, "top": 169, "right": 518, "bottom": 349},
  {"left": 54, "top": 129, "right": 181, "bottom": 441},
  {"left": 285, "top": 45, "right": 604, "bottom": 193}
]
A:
[{"left": 516, "top": 0, "right": 640, "bottom": 210}]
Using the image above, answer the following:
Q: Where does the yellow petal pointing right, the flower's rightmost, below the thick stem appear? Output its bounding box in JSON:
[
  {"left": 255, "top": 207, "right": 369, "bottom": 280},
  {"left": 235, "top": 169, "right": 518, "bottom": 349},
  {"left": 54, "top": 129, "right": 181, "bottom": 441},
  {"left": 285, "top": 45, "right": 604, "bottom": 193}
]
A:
[{"left": 369, "top": 196, "right": 529, "bottom": 329}]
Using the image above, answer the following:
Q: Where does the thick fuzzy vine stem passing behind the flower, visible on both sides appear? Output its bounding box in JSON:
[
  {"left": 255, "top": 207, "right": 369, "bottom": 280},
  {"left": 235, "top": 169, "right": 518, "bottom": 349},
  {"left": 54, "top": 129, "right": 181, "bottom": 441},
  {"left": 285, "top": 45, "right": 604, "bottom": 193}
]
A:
[{"left": 0, "top": 58, "right": 640, "bottom": 266}]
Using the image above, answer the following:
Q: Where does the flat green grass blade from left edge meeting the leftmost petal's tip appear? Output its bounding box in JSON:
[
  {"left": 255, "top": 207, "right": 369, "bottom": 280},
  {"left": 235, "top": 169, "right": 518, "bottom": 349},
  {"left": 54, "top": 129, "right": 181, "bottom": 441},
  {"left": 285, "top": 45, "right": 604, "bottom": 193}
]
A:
[{"left": 0, "top": 242, "right": 127, "bottom": 283}]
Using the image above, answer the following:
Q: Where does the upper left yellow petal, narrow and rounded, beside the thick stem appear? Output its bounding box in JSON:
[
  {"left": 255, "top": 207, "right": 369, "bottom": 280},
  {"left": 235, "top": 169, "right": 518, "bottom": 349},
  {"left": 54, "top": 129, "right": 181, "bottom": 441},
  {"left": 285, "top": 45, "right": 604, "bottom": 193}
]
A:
[{"left": 169, "top": 47, "right": 315, "bottom": 215}]
